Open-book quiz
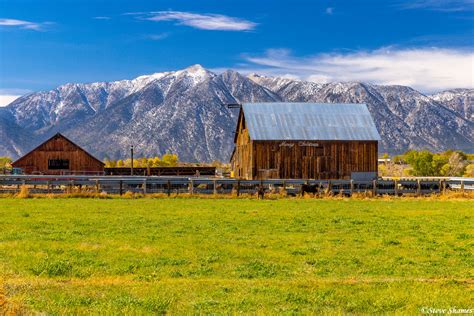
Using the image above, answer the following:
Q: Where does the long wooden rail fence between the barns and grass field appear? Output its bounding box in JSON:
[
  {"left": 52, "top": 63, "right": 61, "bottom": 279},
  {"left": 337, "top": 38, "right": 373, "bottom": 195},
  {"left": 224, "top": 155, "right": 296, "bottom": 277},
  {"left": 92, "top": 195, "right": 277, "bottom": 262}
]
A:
[{"left": 0, "top": 175, "right": 474, "bottom": 195}]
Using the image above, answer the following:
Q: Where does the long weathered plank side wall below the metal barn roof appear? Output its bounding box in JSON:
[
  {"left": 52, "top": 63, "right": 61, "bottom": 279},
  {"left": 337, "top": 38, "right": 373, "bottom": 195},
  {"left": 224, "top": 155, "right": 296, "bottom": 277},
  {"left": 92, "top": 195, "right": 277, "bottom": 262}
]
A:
[{"left": 248, "top": 140, "right": 378, "bottom": 179}]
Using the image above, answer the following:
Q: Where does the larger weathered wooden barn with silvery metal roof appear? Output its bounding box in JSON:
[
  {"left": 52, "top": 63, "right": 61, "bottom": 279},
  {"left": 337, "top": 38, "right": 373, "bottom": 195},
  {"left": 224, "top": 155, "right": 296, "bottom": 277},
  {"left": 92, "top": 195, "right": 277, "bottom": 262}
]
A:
[{"left": 231, "top": 102, "right": 380, "bottom": 180}]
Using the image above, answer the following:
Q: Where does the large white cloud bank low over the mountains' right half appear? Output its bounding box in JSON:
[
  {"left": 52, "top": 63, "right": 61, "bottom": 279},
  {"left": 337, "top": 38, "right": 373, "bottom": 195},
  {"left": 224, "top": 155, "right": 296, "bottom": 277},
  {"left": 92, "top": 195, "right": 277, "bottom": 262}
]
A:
[{"left": 239, "top": 48, "right": 474, "bottom": 92}]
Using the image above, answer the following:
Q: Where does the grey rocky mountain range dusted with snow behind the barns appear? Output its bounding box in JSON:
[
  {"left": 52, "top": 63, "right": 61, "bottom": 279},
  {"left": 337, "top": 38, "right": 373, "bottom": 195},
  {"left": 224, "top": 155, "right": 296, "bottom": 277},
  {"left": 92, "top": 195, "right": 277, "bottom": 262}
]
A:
[{"left": 0, "top": 65, "right": 474, "bottom": 161}]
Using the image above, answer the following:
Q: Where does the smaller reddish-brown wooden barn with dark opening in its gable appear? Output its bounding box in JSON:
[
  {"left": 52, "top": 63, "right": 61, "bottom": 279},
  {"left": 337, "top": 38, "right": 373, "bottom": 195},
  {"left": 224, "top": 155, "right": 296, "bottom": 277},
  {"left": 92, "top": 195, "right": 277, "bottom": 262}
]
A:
[{"left": 12, "top": 133, "right": 104, "bottom": 175}]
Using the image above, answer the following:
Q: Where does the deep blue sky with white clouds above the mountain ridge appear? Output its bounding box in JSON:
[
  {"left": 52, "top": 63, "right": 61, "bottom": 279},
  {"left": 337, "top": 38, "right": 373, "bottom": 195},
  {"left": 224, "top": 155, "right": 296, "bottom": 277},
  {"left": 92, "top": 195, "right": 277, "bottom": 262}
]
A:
[{"left": 0, "top": 0, "right": 474, "bottom": 103}]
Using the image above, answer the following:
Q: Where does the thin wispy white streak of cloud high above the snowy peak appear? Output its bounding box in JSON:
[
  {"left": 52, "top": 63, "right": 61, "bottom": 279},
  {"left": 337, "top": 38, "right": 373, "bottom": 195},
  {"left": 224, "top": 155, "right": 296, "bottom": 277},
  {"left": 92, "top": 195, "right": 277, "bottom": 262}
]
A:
[{"left": 140, "top": 11, "right": 257, "bottom": 31}]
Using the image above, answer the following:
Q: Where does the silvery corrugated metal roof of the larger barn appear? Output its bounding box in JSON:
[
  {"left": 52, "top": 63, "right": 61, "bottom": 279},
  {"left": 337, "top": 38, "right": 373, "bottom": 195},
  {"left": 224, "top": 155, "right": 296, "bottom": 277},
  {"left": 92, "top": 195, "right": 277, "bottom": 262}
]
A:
[{"left": 242, "top": 102, "right": 380, "bottom": 140}]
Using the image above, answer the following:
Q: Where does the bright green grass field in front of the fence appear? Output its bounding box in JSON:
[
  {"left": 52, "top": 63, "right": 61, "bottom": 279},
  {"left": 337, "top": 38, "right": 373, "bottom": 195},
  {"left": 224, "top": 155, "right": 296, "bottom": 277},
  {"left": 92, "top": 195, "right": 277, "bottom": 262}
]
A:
[{"left": 0, "top": 198, "right": 474, "bottom": 315}]
